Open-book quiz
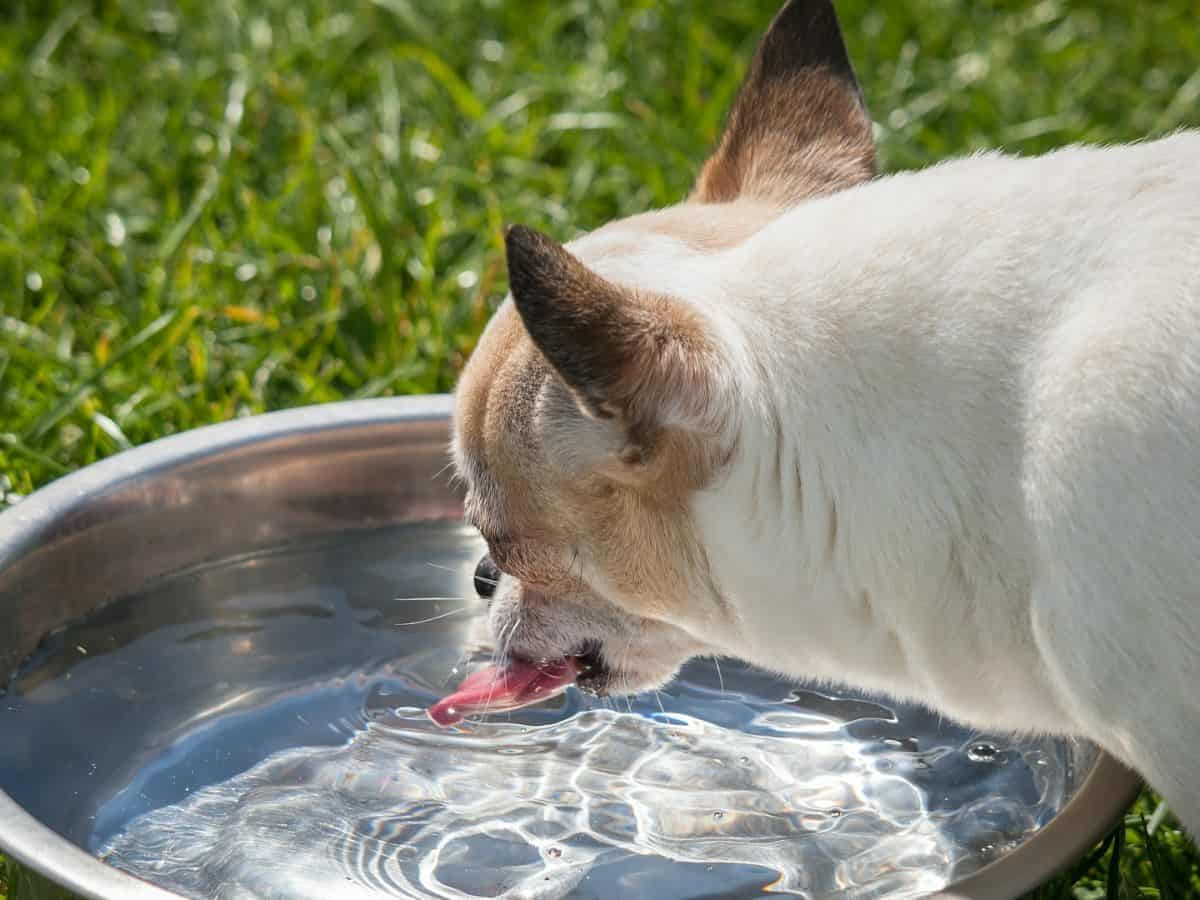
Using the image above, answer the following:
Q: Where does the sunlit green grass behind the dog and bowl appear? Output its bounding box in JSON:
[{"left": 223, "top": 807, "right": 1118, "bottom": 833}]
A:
[{"left": 0, "top": 0, "right": 1200, "bottom": 900}]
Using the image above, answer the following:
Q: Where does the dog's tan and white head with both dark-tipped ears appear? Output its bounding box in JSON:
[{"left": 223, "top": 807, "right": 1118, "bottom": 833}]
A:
[{"left": 454, "top": 0, "right": 875, "bottom": 692}]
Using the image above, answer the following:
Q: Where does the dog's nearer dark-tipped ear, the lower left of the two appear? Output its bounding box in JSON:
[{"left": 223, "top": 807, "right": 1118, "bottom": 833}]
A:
[{"left": 504, "top": 226, "right": 716, "bottom": 461}]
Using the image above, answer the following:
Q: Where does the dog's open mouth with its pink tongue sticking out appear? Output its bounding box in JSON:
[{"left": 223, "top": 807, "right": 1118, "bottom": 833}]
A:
[{"left": 426, "top": 642, "right": 612, "bottom": 727}]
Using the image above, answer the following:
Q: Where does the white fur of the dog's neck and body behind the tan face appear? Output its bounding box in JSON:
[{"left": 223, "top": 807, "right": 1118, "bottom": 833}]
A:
[{"left": 657, "top": 132, "right": 1200, "bottom": 834}]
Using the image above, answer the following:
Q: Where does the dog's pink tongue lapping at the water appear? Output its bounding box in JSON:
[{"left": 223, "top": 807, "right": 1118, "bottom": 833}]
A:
[{"left": 426, "top": 659, "right": 580, "bottom": 727}]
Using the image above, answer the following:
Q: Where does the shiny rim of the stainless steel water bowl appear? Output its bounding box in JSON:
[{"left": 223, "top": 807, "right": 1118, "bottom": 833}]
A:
[{"left": 0, "top": 394, "right": 1141, "bottom": 900}]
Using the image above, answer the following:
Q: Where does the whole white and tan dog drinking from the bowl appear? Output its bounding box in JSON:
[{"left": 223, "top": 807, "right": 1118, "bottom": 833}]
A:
[{"left": 455, "top": 0, "right": 1200, "bottom": 835}]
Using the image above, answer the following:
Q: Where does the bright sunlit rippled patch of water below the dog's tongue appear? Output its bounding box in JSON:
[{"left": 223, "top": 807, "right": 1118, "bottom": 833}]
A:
[{"left": 101, "top": 696, "right": 1094, "bottom": 900}]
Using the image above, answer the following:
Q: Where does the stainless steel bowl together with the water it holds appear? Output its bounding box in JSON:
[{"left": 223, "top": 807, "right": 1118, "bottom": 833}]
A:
[{"left": 0, "top": 401, "right": 1132, "bottom": 898}]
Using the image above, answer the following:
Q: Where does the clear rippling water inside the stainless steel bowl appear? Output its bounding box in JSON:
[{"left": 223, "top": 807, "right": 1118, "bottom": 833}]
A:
[{"left": 0, "top": 523, "right": 1093, "bottom": 900}]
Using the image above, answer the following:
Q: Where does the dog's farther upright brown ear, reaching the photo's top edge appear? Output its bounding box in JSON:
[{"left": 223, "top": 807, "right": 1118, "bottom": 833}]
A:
[{"left": 689, "top": 0, "right": 875, "bottom": 206}]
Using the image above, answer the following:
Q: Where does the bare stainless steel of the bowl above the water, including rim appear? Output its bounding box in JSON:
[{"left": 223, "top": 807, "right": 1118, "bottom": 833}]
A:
[{"left": 0, "top": 396, "right": 1139, "bottom": 900}]
